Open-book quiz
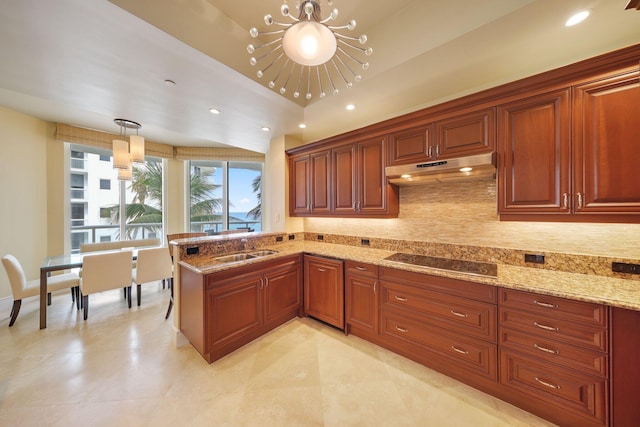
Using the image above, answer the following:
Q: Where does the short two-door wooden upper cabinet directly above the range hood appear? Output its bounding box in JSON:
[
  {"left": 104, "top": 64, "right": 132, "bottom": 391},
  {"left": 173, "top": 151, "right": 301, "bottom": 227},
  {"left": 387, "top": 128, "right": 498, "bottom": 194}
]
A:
[{"left": 389, "top": 107, "right": 496, "bottom": 165}]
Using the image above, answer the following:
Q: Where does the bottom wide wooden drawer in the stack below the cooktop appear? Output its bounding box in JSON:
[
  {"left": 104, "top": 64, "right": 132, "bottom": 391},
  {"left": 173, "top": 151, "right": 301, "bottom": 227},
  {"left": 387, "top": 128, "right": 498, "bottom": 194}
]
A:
[{"left": 380, "top": 310, "right": 497, "bottom": 380}]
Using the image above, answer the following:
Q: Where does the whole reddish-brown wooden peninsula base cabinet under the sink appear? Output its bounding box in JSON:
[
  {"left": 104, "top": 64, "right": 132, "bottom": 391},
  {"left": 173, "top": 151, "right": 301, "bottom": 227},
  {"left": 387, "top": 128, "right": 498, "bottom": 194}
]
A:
[{"left": 180, "top": 255, "right": 302, "bottom": 363}]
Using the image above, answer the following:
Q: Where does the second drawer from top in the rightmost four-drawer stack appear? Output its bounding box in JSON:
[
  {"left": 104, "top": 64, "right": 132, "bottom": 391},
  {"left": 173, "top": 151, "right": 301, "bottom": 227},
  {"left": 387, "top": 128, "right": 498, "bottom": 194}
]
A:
[{"left": 500, "top": 308, "right": 608, "bottom": 352}]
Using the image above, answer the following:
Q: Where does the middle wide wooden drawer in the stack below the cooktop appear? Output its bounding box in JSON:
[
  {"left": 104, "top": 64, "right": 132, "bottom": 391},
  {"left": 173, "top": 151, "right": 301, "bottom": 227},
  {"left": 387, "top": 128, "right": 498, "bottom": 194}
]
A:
[{"left": 380, "top": 281, "right": 497, "bottom": 342}]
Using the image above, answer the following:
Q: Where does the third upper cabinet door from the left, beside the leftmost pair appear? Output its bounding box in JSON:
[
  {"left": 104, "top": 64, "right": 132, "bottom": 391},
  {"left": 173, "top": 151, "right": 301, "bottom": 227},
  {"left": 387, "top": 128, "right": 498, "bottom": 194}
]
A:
[{"left": 331, "top": 144, "right": 358, "bottom": 215}]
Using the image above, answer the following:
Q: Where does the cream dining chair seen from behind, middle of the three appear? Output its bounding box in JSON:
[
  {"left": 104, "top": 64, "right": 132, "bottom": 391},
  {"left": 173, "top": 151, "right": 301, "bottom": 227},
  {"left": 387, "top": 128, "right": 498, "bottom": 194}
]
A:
[{"left": 78, "top": 249, "right": 134, "bottom": 320}]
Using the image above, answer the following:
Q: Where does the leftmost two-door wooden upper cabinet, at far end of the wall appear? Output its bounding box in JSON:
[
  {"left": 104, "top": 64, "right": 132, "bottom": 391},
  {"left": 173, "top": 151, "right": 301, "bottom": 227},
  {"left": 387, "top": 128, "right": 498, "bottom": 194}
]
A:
[{"left": 289, "top": 150, "right": 331, "bottom": 216}]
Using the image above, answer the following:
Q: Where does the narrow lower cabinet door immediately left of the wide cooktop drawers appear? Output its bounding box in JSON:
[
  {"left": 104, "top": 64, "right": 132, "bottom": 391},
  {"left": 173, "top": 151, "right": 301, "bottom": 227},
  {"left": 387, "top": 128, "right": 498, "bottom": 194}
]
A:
[{"left": 345, "top": 274, "right": 378, "bottom": 336}]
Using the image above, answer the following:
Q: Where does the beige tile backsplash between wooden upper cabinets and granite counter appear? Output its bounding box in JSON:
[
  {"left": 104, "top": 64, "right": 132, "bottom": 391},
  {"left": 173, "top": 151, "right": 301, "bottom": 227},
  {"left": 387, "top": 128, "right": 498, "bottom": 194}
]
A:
[{"left": 304, "top": 179, "right": 640, "bottom": 270}]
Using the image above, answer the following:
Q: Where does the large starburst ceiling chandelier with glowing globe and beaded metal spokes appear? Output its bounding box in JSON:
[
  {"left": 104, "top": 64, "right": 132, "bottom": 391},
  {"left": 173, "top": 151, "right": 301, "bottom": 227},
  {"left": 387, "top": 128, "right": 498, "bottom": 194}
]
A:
[{"left": 247, "top": 0, "right": 373, "bottom": 100}]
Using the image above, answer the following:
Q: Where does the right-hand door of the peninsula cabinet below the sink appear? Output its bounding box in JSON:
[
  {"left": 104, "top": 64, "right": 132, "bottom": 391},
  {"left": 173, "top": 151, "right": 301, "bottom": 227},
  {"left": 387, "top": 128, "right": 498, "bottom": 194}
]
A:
[{"left": 263, "top": 262, "right": 302, "bottom": 324}]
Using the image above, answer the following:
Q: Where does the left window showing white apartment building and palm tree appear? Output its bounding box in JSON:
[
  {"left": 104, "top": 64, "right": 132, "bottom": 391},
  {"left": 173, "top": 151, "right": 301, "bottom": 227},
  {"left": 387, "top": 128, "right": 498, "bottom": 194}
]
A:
[{"left": 69, "top": 144, "right": 164, "bottom": 252}]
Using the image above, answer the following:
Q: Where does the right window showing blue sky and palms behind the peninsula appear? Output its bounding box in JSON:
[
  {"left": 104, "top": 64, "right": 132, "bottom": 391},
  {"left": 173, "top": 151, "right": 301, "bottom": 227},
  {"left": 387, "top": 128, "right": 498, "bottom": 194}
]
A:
[{"left": 189, "top": 161, "right": 263, "bottom": 234}]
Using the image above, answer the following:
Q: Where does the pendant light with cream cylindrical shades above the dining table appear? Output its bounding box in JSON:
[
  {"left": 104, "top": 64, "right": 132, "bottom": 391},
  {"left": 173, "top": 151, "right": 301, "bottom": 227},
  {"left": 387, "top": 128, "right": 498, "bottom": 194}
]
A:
[{"left": 113, "top": 119, "right": 144, "bottom": 181}]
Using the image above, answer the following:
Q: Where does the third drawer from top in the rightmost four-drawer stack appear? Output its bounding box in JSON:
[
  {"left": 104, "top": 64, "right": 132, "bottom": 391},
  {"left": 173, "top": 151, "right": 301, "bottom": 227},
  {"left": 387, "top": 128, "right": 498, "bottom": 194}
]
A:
[{"left": 499, "top": 328, "right": 608, "bottom": 378}]
